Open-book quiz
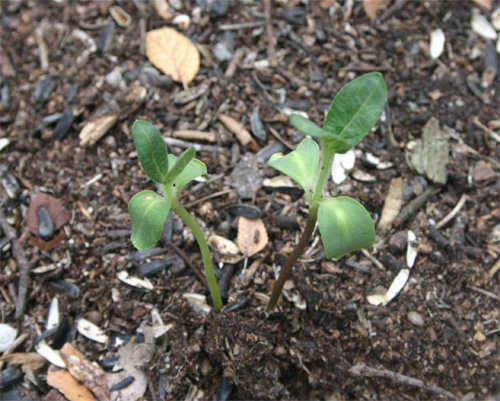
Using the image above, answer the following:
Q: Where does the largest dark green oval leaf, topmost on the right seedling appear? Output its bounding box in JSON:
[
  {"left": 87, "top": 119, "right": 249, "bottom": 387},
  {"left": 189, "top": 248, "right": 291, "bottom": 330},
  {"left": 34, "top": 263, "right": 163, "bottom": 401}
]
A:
[{"left": 324, "top": 72, "right": 387, "bottom": 153}]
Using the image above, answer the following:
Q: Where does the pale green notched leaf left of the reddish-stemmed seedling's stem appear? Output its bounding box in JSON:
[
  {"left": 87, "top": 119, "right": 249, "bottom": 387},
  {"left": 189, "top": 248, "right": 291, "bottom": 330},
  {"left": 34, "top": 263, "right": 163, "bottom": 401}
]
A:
[{"left": 267, "top": 138, "right": 319, "bottom": 196}]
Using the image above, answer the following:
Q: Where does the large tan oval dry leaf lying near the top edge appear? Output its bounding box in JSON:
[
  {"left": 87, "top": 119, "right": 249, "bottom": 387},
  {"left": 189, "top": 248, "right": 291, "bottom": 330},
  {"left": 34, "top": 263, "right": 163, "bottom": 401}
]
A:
[{"left": 146, "top": 28, "right": 200, "bottom": 85}]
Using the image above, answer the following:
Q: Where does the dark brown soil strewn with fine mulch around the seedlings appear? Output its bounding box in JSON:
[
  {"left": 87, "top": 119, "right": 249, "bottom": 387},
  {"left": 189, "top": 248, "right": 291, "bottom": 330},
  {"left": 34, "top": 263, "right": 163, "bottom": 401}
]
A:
[{"left": 0, "top": 0, "right": 500, "bottom": 400}]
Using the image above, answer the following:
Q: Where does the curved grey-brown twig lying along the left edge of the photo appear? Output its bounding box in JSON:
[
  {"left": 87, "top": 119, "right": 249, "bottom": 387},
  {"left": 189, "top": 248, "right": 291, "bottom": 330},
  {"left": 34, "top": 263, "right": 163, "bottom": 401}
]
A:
[{"left": 0, "top": 209, "right": 31, "bottom": 319}]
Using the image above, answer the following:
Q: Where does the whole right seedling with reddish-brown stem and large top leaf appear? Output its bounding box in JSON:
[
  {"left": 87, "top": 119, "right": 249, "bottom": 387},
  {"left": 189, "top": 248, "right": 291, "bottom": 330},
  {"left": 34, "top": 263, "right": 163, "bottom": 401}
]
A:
[{"left": 267, "top": 72, "right": 387, "bottom": 312}]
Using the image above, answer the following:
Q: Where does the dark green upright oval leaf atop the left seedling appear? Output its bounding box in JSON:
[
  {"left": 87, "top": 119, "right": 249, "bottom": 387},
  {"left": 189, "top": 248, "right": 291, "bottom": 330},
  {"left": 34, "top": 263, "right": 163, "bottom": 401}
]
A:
[{"left": 132, "top": 120, "right": 168, "bottom": 184}]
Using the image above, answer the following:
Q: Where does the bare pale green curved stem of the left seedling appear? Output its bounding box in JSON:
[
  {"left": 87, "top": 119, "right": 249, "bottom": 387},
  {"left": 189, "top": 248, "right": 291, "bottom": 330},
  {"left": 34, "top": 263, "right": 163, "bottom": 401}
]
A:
[{"left": 172, "top": 199, "right": 222, "bottom": 313}]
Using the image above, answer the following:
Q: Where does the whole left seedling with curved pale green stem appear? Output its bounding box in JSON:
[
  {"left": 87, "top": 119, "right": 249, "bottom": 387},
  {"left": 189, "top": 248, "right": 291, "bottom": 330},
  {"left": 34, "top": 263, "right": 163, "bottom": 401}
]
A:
[{"left": 128, "top": 120, "right": 222, "bottom": 313}]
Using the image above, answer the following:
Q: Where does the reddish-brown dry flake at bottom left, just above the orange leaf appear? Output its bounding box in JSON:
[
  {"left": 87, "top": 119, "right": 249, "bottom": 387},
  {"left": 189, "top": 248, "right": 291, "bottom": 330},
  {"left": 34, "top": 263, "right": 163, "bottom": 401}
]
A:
[{"left": 60, "top": 343, "right": 109, "bottom": 400}]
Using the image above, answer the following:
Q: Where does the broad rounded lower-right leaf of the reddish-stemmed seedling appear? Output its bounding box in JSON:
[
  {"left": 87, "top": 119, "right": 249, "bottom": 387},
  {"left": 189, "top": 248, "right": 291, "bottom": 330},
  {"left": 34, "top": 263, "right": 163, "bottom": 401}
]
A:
[{"left": 318, "top": 196, "right": 375, "bottom": 259}]
